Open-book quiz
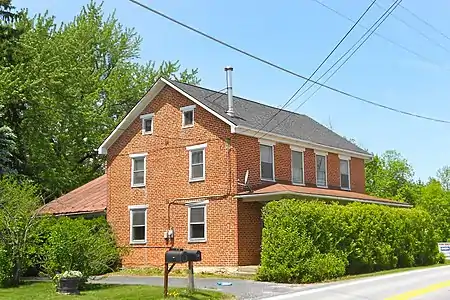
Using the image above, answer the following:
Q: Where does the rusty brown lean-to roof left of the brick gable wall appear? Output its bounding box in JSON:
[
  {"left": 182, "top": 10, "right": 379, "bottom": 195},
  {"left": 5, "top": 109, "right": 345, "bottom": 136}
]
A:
[{"left": 41, "top": 175, "right": 108, "bottom": 215}]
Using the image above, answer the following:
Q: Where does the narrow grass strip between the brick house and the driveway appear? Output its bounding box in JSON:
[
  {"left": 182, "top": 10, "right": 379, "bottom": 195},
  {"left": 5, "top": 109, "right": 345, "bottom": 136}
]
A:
[{"left": 106, "top": 267, "right": 255, "bottom": 280}]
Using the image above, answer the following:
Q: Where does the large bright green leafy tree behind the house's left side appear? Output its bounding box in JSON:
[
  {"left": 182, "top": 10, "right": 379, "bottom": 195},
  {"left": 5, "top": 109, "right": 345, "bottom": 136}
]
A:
[{"left": 0, "top": 2, "right": 199, "bottom": 199}]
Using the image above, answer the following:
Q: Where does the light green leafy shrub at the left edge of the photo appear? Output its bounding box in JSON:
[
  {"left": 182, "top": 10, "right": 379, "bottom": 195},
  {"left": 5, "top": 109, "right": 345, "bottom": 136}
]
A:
[{"left": 0, "top": 176, "right": 42, "bottom": 286}]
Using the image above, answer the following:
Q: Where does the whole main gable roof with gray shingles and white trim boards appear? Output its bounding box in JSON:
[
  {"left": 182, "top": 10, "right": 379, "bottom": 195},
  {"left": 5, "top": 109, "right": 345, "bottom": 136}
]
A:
[{"left": 98, "top": 78, "right": 372, "bottom": 158}]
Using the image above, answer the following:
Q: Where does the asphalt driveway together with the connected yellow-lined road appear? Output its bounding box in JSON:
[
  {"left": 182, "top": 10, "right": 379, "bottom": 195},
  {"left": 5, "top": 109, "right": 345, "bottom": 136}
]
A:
[{"left": 91, "top": 266, "right": 450, "bottom": 300}]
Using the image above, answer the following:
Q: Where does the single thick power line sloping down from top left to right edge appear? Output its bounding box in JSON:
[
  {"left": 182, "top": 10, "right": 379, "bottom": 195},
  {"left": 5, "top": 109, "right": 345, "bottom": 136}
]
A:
[{"left": 129, "top": 0, "right": 450, "bottom": 124}]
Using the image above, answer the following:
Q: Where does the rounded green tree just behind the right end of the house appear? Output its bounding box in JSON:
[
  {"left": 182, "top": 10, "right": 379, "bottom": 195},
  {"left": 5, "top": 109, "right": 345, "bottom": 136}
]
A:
[{"left": 366, "top": 150, "right": 420, "bottom": 203}]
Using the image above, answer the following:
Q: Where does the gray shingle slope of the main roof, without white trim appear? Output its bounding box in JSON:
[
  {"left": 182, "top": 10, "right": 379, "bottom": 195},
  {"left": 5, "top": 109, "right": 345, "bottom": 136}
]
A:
[{"left": 170, "top": 80, "right": 370, "bottom": 155}]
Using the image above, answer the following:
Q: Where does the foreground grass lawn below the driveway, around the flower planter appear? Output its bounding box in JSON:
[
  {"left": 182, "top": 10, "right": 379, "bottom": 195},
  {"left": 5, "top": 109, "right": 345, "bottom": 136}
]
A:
[{"left": 0, "top": 282, "right": 234, "bottom": 300}]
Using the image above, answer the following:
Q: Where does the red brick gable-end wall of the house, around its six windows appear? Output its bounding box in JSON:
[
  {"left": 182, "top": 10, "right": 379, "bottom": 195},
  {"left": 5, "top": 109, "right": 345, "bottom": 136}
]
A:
[{"left": 107, "top": 87, "right": 238, "bottom": 266}]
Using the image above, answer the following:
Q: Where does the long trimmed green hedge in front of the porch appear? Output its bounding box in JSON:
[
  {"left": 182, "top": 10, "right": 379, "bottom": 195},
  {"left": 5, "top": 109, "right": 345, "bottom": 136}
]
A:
[{"left": 258, "top": 199, "right": 442, "bottom": 283}]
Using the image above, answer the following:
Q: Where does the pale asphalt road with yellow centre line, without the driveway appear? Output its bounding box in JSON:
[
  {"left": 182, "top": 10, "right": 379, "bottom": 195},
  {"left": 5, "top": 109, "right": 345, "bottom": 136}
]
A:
[{"left": 265, "top": 266, "right": 450, "bottom": 300}]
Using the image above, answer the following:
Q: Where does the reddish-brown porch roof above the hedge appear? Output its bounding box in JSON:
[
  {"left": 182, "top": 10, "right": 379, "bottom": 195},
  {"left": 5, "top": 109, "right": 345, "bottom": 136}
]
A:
[{"left": 237, "top": 183, "right": 411, "bottom": 207}]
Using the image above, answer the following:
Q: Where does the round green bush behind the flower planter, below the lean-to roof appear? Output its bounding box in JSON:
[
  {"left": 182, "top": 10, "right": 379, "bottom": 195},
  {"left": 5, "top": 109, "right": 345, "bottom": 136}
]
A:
[{"left": 42, "top": 217, "right": 120, "bottom": 277}]
